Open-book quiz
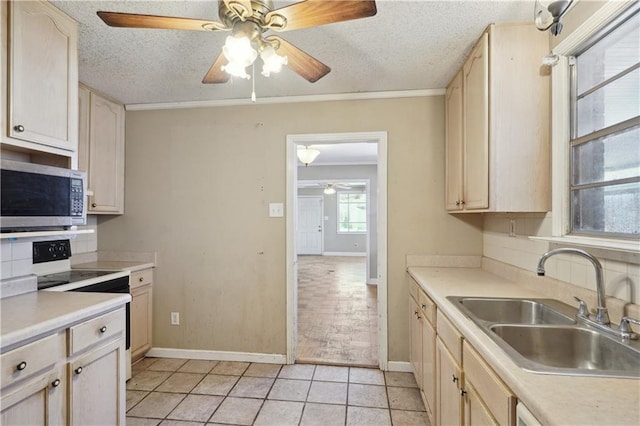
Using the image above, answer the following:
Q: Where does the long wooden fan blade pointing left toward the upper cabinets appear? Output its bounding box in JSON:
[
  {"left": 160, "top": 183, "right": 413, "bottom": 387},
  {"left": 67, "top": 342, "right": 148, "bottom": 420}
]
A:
[{"left": 98, "top": 12, "right": 228, "bottom": 31}]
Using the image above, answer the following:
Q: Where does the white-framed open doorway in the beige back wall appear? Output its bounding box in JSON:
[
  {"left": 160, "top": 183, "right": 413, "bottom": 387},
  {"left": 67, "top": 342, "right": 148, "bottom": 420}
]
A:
[{"left": 287, "top": 132, "right": 387, "bottom": 369}]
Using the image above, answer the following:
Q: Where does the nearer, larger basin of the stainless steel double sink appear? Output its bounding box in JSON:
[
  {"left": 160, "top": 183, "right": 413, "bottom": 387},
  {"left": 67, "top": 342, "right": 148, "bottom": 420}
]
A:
[{"left": 490, "top": 325, "right": 640, "bottom": 377}]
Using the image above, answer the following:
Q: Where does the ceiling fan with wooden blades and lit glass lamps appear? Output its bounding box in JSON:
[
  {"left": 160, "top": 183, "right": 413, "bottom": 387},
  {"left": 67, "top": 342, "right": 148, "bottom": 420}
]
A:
[{"left": 98, "top": 0, "right": 377, "bottom": 83}]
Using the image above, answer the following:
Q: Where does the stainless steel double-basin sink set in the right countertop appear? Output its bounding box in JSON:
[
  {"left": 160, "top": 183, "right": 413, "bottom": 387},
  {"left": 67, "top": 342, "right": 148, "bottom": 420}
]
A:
[{"left": 447, "top": 296, "right": 640, "bottom": 377}]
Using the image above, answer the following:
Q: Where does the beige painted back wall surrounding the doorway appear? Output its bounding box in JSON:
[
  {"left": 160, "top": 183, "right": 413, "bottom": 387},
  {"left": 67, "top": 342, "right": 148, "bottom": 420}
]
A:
[{"left": 99, "top": 96, "right": 482, "bottom": 361}]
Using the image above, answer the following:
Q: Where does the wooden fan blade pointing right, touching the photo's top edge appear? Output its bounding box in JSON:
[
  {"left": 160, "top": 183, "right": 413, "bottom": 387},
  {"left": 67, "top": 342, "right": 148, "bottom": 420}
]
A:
[{"left": 265, "top": 0, "right": 377, "bottom": 31}]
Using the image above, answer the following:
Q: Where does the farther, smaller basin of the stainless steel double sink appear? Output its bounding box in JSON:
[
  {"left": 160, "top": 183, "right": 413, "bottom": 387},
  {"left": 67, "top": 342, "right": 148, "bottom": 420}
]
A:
[{"left": 449, "top": 296, "right": 575, "bottom": 325}]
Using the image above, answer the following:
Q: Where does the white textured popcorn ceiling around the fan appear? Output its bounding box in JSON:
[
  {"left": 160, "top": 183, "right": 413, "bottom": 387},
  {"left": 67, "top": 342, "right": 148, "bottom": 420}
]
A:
[{"left": 52, "top": 0, "right": 534, "bottom": 104}]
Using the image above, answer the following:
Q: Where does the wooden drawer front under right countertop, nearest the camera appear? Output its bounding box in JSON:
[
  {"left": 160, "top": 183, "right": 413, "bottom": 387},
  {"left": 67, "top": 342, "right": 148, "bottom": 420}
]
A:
[{"left": 463, "top": 342, "right": 516, "bottom": 425}]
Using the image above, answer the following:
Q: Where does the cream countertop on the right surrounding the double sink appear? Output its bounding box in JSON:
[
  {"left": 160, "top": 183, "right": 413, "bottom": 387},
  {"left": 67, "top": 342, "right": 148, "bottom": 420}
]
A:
[{"left": 409, "top": 267, "right": 640, "bottom": 425}]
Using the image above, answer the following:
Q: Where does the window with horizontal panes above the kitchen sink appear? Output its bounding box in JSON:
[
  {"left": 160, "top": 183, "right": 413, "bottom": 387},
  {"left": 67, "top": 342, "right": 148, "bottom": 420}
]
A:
[{"left": 570, "top": 11, "right": 640, "bottom": 238}]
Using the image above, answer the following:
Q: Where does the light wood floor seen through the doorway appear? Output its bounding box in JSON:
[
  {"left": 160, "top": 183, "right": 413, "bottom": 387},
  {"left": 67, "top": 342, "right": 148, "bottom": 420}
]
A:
[{"left": 296, "top": 256, "right": 378, "bottom": 367}]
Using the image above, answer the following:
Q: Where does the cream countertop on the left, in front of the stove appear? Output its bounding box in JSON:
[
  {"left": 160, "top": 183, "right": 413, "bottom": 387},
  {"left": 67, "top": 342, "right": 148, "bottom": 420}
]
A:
[{"left": 0, "top": 291, "right": 131, "bottom": 352}]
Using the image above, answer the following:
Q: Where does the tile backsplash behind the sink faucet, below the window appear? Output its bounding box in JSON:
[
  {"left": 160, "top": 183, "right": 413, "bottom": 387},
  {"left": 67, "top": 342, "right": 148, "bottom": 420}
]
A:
[{"left": 483, "top": 214, "right": 640, "bottom": 304}]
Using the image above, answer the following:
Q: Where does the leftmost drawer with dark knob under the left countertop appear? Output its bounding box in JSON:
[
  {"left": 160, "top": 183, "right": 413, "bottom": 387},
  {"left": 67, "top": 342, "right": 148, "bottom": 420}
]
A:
[{"left": 0, "top": 332, "right": 66, "bottom": 388}]
